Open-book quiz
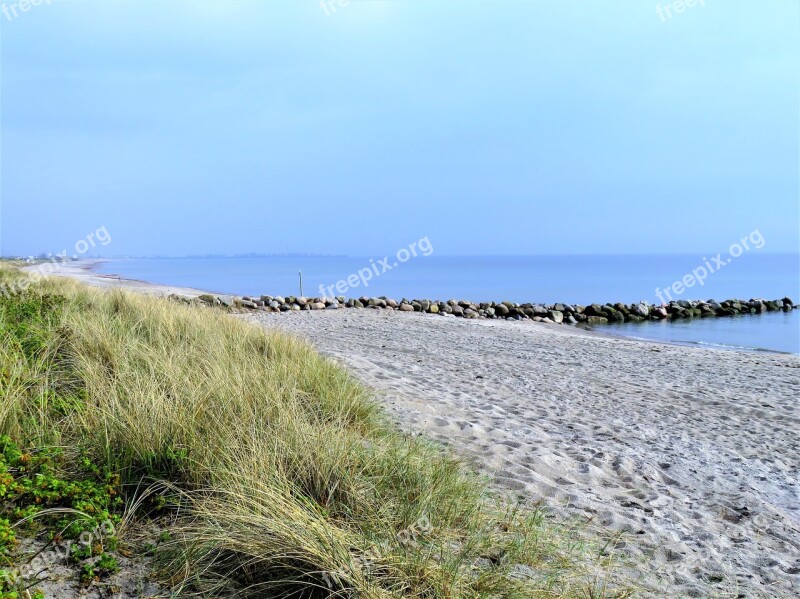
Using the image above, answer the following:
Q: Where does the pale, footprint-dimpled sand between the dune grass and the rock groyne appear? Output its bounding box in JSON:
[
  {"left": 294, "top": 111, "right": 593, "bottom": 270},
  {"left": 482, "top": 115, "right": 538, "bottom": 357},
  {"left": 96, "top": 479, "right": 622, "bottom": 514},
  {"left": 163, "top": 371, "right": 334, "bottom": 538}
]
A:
[{"left": 244, "top": 310, "right": 800, "bottom": 597}]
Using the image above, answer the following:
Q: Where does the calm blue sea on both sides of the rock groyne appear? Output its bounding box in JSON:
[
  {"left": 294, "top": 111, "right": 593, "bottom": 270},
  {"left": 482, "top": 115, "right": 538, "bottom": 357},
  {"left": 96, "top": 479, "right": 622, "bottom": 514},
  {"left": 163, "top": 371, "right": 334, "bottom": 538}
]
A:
[{"left": 100, "top": 253, "right": 800, "bottom": 353}]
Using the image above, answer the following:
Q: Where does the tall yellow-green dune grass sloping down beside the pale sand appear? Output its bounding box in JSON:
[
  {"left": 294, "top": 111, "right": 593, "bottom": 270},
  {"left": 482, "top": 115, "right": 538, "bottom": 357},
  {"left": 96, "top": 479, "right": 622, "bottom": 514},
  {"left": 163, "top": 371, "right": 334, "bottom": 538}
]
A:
[{"left": 0, "top": 267, "right": 626, "bottom": 598}]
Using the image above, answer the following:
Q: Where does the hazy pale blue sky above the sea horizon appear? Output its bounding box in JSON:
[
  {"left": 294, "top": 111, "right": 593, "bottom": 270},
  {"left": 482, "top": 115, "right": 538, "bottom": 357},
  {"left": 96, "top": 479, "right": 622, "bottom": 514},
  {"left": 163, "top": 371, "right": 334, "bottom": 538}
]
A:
[{"left": 0, "top": 0, "right": 800, "bottom": 256}]
